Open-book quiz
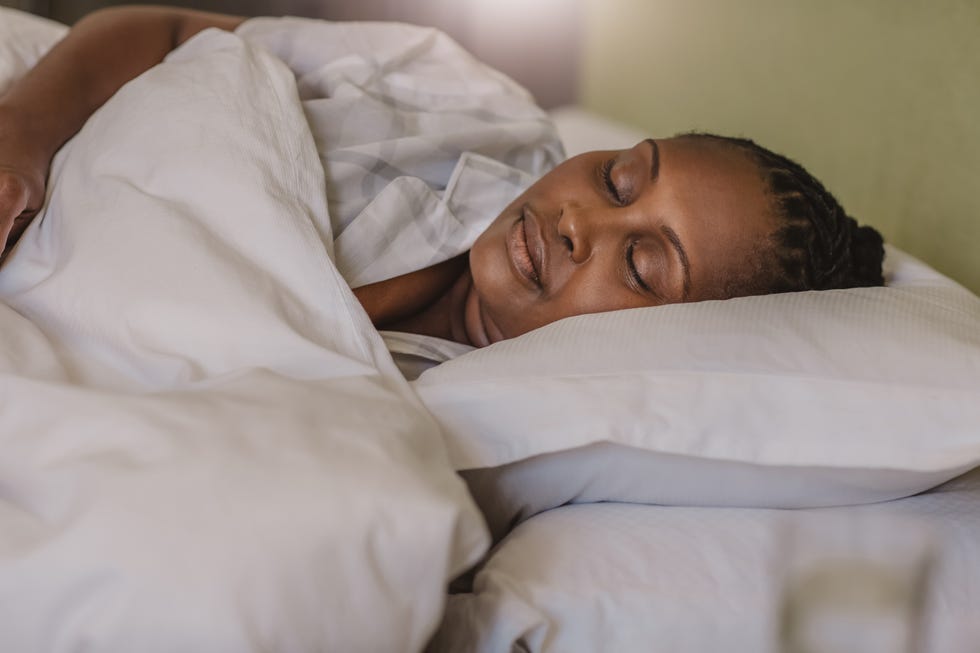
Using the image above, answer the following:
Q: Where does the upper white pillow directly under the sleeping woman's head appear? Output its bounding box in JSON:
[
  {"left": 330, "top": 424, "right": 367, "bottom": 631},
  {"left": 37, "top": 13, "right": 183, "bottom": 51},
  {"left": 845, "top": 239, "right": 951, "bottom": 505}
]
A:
[{"left": 415, "top": 249, "right": 980, "bottom": 536}]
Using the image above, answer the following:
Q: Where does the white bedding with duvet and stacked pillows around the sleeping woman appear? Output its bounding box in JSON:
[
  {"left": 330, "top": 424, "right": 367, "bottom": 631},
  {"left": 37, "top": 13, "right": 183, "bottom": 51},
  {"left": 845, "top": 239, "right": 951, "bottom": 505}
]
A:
[{"left": 0, "top": 10, "right": 980, "bottom": 653}]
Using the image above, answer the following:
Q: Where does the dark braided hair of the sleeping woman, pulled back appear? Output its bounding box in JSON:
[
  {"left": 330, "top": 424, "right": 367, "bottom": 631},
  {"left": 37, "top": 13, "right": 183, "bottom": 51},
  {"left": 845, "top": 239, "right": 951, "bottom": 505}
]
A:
[{"left": 681, "top": 132, "right": 884, "bottom": 297}]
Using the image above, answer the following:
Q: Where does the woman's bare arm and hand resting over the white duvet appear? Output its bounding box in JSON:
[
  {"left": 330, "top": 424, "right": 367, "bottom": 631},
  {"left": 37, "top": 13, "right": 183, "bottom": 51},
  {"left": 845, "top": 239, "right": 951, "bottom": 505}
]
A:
[{"left": 0, "top": 7, "right": 243, "bottom": 255}]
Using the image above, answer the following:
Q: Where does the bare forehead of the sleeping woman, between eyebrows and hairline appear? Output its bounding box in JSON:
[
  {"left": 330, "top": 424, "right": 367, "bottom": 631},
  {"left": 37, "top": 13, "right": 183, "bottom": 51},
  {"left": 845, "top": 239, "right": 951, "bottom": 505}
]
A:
[{"left": 657, "top": 136, "right": 777, "bottom": 299}]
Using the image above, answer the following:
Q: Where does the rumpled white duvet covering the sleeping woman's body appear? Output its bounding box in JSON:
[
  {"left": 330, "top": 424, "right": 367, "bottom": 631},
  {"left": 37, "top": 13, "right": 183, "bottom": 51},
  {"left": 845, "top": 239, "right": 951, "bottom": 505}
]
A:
[{"left": 0, "top": 12, "right": 486, "bottom": 653}]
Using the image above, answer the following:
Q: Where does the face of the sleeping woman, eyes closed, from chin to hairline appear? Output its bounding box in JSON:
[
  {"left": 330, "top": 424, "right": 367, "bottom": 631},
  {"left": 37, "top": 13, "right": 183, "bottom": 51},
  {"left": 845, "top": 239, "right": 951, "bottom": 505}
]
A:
[{"left": 464, "top": 137, "right": 776, "bottom": 346}]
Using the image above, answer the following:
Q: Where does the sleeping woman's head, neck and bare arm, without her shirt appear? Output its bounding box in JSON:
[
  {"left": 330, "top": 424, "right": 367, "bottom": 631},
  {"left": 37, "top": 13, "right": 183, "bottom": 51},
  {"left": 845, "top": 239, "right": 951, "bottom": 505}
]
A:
[{"left": 0, "top": 7, "right": 883, "bottom": 356}]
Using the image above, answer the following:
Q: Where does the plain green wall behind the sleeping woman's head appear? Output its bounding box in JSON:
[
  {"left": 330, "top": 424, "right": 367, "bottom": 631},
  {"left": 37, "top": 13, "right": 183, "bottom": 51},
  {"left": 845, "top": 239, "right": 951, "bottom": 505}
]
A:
[{"left": 580, "top": 0, "right": 980, "bottom": 292}]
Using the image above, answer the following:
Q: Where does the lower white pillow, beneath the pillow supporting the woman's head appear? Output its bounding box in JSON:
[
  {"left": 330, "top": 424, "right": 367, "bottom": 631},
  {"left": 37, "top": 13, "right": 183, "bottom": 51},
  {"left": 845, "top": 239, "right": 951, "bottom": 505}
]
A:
[{"left": 429, "top": 470, "right": 980, "bottom": 653}]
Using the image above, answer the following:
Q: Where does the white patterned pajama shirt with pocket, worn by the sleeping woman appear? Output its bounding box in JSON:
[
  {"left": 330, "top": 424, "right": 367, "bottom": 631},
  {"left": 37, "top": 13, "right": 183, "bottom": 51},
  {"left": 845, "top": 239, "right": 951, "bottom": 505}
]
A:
[{"left": 237, "top": 18, "right": 564, "bottom": 288}]
